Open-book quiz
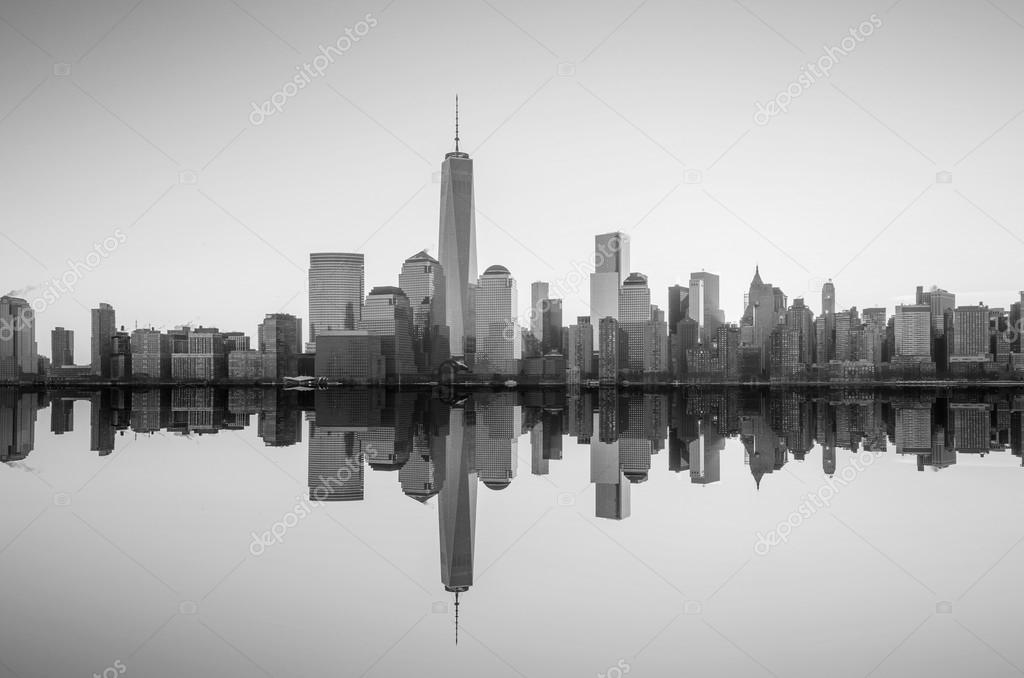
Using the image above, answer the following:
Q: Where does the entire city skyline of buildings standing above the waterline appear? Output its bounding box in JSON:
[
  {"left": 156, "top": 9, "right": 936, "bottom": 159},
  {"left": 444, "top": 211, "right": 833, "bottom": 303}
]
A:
[{"left": 6, "top": 113, "right": 1024, "bottom": 385}]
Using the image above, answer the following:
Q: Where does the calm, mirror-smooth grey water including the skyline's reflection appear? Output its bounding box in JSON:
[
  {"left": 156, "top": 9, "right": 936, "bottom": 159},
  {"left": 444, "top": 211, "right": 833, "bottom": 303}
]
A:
[{"left": 0, "top": 389, "right": 1024, "bottom": 678}]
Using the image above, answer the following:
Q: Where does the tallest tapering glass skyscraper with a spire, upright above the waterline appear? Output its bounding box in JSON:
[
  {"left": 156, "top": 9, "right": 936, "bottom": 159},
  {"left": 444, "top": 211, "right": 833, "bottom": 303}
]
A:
[{"left": 437, "top": 99, "right": 477, "bottom": 355}]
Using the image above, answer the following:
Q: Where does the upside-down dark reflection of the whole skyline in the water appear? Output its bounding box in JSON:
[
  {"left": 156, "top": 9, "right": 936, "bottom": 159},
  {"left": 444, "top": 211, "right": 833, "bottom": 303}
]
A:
[{"left": 0, "top": 388, "right": 1024, "bottom": 634}]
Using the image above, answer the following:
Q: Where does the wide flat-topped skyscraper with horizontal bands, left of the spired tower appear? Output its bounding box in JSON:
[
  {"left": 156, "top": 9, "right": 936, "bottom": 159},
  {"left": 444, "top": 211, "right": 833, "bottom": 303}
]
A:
[{"left": 309, "top": 252, "right": 366, "bottom": 344}]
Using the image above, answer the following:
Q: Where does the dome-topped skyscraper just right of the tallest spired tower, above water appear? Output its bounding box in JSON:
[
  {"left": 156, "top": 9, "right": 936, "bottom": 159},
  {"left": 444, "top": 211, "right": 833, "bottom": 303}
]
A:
[{"left": 471, "top": 264, "right": 522, "bottom": 375}]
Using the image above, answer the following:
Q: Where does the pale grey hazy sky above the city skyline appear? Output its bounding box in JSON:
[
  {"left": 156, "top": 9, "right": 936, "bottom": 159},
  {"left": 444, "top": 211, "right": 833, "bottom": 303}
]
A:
[{"left": 0, "top": 0, "right": 1024, "bottom": 363}]
